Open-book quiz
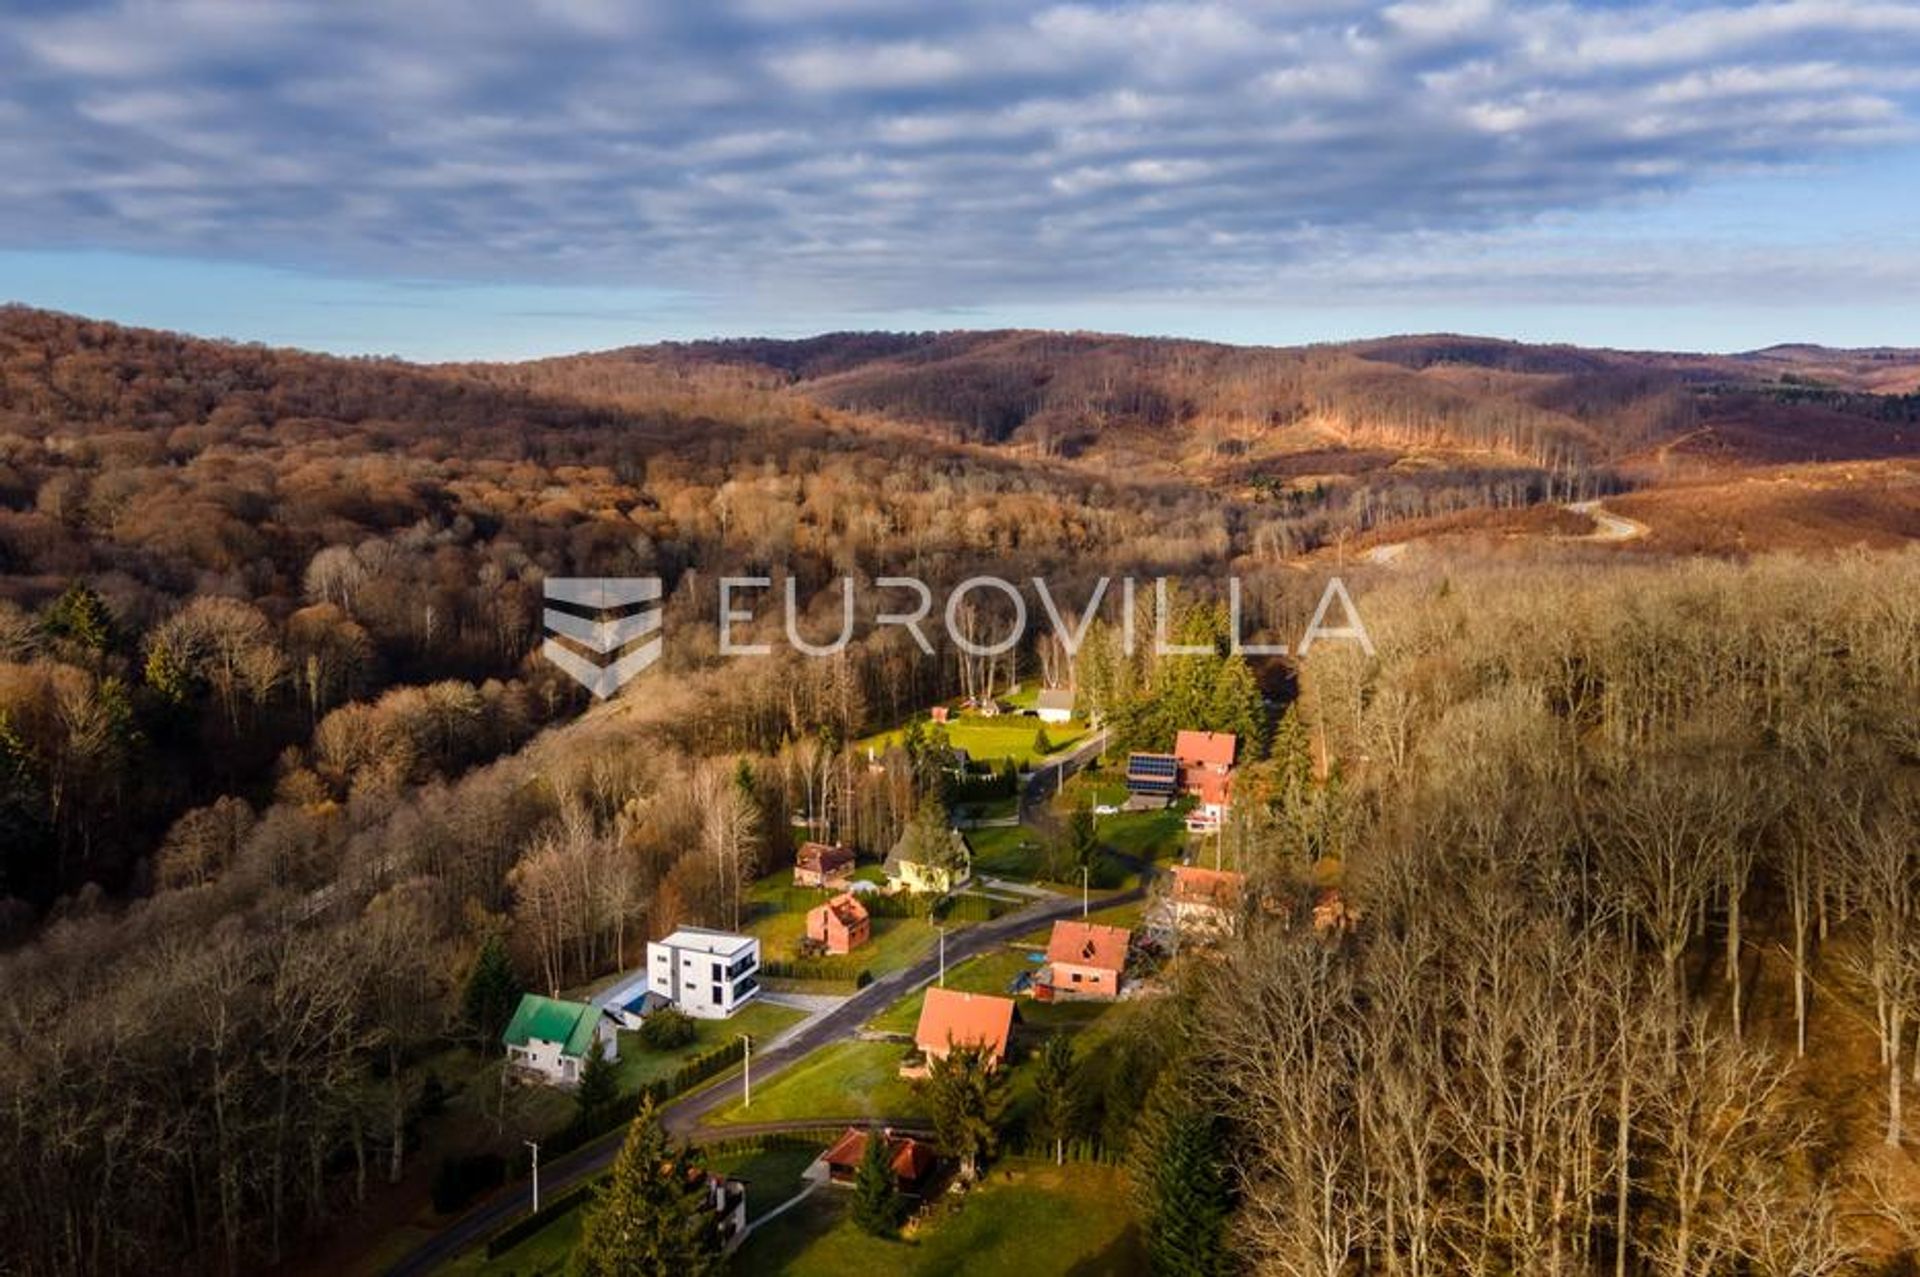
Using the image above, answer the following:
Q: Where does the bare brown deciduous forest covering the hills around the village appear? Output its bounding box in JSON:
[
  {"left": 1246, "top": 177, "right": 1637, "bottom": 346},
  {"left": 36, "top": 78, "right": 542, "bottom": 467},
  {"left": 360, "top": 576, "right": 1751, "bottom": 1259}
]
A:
[{"left": 0, "top": 309, "right": 1920, "bottom": 1277}]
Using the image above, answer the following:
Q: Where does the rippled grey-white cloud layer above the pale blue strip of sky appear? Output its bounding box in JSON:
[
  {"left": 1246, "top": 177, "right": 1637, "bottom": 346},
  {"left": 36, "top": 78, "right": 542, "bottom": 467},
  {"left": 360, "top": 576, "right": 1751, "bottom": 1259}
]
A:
[{"left": 0, "top": 0, "right": 1920, "bottom": 305}]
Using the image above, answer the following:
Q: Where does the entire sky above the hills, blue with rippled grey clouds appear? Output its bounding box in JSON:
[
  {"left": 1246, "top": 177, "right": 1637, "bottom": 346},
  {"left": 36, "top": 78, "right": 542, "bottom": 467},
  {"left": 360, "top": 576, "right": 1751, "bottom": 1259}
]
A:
[{"left": 0, "top": 0, "right": 1920, "bottom": 357}]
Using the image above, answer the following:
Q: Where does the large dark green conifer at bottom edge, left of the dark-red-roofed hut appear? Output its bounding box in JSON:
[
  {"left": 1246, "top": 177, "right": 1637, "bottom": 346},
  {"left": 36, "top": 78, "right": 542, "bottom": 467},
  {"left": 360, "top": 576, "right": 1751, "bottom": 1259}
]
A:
[{"left": 568, "top": 1098, "right": 720, "bottom": 1277}]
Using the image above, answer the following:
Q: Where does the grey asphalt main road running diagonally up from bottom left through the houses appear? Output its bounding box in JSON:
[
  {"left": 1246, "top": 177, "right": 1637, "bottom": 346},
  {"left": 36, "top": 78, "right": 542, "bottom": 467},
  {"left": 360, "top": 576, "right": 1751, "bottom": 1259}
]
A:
[{"left": 386, "top": 875, "right": 1144, "bottom": 1277}]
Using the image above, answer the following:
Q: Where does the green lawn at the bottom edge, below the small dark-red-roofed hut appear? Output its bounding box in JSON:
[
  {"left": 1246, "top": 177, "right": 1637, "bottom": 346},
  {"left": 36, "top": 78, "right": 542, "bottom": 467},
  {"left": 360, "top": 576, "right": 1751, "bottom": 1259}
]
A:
[{"left": 732, "top": 1160, "right": 1146, "bottom": 1277}]
